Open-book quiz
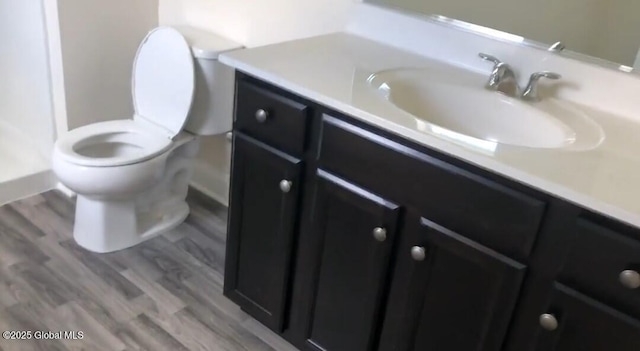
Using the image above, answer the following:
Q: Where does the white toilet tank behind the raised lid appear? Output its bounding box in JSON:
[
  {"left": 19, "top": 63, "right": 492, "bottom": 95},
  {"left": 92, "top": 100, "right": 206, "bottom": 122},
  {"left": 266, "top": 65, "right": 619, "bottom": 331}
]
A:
[{"left": 176, "top": 27, "right": 242, "bottom": 135}]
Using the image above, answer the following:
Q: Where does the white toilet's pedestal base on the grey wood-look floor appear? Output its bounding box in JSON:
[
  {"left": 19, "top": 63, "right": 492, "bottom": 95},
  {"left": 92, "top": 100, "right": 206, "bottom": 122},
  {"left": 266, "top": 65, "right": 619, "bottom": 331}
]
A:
[{"left": 66, "top": 139, "right": 200, "bottom": 253}]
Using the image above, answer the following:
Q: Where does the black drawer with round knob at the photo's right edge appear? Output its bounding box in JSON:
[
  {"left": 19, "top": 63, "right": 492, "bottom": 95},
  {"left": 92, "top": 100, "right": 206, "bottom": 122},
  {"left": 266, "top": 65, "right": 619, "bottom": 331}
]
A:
[{"left": 559, "top": 217, "right": 640, "bottom": 317}]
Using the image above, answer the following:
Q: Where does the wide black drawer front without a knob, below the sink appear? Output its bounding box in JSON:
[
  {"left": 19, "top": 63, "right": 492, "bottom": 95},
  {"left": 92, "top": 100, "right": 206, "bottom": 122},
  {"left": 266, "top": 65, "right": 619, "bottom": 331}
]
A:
[{"left": 319, "top": 115, "right": 546, "bottom": 259}]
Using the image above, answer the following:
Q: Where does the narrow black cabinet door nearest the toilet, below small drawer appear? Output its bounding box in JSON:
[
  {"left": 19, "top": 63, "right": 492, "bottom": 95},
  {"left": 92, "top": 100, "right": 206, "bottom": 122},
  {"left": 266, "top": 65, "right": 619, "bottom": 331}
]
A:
[{"left": 224, "top": 133, "right": 302, "bottom": 331}]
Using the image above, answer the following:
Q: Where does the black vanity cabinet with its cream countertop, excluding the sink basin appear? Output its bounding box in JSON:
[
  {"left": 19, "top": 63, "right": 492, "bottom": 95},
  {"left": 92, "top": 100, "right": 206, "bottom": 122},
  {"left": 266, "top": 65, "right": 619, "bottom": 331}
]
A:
[{"left": 221, "top": 11, "right": 640, "bottom": 351}]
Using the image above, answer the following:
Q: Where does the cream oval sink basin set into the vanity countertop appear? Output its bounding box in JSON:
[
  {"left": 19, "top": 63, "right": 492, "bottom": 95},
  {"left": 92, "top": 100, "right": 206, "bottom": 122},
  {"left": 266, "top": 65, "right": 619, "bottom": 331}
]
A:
[{"left": 368, "top": 69, "right": 604, "bottom": 149}]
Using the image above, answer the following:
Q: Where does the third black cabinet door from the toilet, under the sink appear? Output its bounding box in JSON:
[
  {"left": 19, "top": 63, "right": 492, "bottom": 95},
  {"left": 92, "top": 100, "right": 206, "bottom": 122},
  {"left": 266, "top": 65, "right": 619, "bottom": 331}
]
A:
[{"left": 380, "top": 215, "right": 525, "bottom": 351}]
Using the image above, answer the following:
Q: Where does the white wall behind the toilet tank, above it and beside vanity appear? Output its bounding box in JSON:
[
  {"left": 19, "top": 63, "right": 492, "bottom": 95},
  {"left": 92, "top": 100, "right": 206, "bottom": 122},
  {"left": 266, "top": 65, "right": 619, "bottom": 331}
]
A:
[{"left": 159, "top": 0, "right": 354, "bottom": 203}]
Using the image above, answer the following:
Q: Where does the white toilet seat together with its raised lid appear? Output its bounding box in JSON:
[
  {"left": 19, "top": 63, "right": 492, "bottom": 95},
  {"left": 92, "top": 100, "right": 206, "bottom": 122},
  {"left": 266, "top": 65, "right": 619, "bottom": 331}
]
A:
[{"left": 54, "top": 27, "right": 195, "bottom": 167}]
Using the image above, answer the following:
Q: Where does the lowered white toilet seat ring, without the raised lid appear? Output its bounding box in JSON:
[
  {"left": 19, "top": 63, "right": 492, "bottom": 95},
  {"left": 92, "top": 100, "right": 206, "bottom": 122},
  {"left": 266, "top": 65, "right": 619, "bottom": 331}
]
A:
[{"left": 54, "top": 120, "right": 172, "bottom": 167}]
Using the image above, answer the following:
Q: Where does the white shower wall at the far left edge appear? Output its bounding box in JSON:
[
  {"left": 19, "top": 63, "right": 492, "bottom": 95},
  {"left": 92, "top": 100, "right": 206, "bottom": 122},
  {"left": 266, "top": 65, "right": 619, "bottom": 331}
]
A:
[{"left": 0, "top": 0, "right": 54, "bottom": 157}]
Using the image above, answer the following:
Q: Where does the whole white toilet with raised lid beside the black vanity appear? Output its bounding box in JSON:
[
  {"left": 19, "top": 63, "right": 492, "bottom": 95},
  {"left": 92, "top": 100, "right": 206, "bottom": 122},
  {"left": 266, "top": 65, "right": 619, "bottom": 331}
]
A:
[{"left": 52, "top": 27, "right": 241, "bottom": 253}]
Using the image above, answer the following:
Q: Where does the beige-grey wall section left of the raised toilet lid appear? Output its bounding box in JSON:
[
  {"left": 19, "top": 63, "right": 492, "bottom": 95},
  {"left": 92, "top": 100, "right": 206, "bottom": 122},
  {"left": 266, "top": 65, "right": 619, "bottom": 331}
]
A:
[{"left": 56, "top": 0, "right": 158, "bottom": 129}]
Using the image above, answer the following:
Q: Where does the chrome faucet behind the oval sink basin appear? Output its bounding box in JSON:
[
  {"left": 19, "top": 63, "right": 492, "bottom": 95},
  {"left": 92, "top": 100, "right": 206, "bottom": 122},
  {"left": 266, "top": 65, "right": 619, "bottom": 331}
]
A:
[{"left": 478, "top": 53, "right": 562, "bottom": 102}]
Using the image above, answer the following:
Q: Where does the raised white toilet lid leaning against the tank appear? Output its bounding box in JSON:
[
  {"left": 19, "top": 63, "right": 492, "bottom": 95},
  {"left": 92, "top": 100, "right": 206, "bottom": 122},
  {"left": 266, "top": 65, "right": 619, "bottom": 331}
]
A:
[{"left": 132, "top": 27, "right": 195, "bottom": 138}]
